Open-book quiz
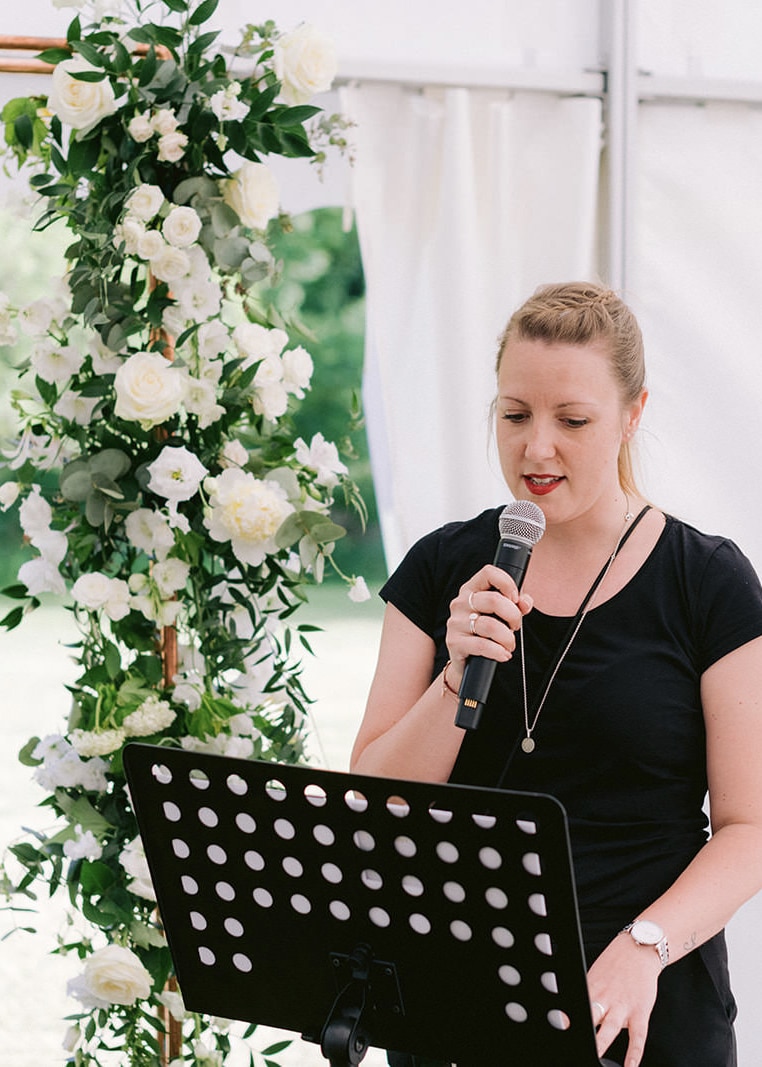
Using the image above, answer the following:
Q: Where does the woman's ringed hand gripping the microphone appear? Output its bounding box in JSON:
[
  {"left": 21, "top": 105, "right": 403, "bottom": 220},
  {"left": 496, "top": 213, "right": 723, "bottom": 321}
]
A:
[{"left": 446, "top": 563, "right": 533, "bottom": 688}]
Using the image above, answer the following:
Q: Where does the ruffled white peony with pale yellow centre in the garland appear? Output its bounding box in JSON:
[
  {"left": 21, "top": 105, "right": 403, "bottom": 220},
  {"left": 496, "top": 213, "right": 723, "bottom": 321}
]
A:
[{"left": 204, "top": 467, "right": 293, "bottom": 567}]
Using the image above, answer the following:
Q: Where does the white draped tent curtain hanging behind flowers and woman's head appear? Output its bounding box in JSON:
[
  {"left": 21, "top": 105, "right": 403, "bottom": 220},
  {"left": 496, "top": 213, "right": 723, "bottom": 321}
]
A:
[{"left": 343, "top": 85, "right": 602, "bottom": 569}]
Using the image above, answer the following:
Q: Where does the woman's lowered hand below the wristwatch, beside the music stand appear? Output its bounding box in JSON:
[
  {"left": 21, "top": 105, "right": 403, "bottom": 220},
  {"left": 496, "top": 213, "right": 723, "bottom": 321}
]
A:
[{"left": 587, "top": 934, "right": 662, "bottom": 1067}]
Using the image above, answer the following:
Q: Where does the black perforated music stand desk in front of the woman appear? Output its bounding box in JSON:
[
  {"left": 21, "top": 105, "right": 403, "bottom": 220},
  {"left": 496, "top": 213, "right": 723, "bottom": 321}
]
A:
[{"left": 125, "top": 744, "right": 605, "bottom": 1067}]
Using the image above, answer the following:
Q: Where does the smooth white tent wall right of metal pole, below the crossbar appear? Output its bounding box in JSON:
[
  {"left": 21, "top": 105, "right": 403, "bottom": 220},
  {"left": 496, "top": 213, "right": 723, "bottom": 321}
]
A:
[{"left": 629, "top": 103, "right": 762, "bottom": 573}]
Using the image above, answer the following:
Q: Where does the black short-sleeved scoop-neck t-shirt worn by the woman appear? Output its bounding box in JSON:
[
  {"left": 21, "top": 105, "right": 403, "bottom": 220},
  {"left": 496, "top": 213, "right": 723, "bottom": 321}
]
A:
[{"left": 381, "top": 508, "right": 762, "bottom": 936}]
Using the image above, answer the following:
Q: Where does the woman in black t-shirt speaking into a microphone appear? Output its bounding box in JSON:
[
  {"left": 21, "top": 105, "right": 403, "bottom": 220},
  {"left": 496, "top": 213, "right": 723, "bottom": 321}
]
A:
[{"left": 352, "top": 284, "right": 762, "bottom": 1067}]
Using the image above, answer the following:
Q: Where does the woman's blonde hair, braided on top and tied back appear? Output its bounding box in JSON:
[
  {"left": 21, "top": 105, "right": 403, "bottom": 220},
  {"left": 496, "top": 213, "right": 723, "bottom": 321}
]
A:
[{"left": 495, "top": 282, "right": 646, "bottom": 495}]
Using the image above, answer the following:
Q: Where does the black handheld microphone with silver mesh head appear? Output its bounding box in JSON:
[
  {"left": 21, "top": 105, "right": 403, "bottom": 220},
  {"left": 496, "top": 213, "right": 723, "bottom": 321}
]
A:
[{"left": 455, "top": 500, "right": 545, "bottom": 730}]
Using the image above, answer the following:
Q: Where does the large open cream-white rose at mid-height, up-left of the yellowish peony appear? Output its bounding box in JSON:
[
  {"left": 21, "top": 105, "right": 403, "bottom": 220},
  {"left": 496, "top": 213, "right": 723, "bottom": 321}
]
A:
[{"left": 114, "top": 352, "right": 186, "bottom": 430}]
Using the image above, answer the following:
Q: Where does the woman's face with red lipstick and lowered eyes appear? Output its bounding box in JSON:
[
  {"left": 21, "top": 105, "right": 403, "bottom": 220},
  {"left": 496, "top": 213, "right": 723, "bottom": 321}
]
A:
[{"left": 496, "top": 339, "right": 646, "bottom": 523}]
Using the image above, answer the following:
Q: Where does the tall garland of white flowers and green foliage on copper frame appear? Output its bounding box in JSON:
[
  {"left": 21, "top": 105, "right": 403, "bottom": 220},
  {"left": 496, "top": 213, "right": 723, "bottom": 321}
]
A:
[{"left": 0, "top": 0, "right": 367, "bottom": 1067}]
